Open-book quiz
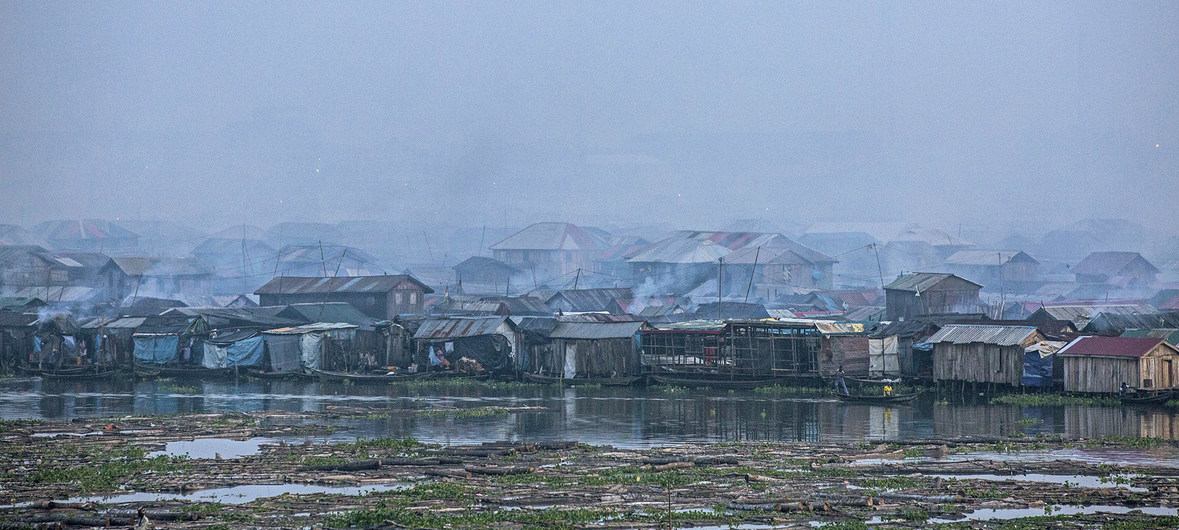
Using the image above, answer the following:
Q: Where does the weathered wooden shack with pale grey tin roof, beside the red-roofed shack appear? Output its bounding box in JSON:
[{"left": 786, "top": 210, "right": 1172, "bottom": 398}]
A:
[{"left": 928, "top": 324, "right": 1045, "bottom": 386}]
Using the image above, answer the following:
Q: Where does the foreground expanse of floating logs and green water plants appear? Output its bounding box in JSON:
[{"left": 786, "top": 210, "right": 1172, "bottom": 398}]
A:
[{"left": 0, "top": 409, "right": 1179, "bottom": 529}]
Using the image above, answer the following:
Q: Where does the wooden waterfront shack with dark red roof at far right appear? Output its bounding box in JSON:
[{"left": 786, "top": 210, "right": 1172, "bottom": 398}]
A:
[{"left": 1058, "top": 337, "right": 1179, "bottom": 393}]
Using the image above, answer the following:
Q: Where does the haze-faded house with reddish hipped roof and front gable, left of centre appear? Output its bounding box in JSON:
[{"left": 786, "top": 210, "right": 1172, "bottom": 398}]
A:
[{"left": 490, "top": 223, "right": 610, "bottom": 285}]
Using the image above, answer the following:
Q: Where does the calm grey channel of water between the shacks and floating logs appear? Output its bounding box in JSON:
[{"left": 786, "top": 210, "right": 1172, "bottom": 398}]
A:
[{"left": 0, "top": 379, "right": 1179, "bottom": 452}]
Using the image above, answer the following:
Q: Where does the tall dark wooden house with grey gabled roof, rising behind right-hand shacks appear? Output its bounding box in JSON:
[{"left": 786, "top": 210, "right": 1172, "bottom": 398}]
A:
[{"left": 884, "top": 272, "right": 983, "bottom": 320}]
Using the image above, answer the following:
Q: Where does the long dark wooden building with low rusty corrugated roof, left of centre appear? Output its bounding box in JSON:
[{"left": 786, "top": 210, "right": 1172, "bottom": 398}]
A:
[{"left": 253, "top": 274, "right": 434, "bottom": 320}]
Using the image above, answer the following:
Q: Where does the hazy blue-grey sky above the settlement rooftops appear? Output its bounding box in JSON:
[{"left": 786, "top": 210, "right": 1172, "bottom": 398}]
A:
[{"left": 0, "top": 1, "right": 1179, "bottom": 233}]
